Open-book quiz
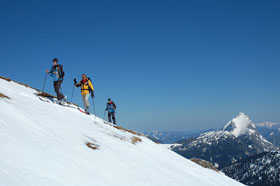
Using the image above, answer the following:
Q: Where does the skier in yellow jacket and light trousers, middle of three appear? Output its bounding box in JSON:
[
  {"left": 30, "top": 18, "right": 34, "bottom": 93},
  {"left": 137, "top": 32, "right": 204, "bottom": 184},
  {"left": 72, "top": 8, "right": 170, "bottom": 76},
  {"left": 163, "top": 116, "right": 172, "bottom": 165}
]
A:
[{"left": 74, "top": 74, "right": 94, "bottom": 115}]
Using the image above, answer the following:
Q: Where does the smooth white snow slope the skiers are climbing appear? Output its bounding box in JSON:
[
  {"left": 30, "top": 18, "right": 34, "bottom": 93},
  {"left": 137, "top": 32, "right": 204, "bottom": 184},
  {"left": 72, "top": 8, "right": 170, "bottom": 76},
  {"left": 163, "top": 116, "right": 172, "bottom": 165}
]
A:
[{"left": 0, "top": 78, "right": 242, "bottom": 186}]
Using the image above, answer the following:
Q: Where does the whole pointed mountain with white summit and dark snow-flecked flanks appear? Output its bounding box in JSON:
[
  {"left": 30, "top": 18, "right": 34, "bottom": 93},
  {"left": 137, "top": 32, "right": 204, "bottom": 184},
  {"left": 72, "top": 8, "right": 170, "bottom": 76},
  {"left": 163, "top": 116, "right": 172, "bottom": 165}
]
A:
[{"left": 171, "top": 113, "right": 277, "bottom": 168}]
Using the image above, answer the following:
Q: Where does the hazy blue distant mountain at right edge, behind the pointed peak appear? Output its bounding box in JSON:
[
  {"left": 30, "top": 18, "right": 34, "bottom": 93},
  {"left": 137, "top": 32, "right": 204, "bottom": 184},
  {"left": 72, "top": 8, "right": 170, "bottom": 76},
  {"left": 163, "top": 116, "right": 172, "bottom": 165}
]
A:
[{"left": 256, "top": 122, "right": 280, "bottom": 147}]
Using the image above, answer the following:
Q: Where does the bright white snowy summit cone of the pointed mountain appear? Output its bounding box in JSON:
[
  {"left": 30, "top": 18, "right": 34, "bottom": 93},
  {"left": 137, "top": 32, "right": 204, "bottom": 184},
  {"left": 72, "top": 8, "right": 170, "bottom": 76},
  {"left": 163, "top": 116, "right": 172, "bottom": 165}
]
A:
[{"left": 223, "top": 112, "right": 256, "bottom": 137}]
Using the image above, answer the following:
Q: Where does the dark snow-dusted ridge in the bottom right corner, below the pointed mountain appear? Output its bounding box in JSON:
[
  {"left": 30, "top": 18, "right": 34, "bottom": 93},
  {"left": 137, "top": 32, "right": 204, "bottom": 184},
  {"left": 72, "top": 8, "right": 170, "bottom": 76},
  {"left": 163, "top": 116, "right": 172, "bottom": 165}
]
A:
[{"left": 222, "top": 152, "right": 280, "bottom": 186}]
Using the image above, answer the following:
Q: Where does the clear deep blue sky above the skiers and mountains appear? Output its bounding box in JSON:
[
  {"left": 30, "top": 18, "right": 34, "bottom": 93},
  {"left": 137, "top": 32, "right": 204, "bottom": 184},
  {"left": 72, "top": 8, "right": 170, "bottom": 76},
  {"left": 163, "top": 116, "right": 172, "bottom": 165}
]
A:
[{"left": 0, "top": 0, "right": 280, "bottom": 131}]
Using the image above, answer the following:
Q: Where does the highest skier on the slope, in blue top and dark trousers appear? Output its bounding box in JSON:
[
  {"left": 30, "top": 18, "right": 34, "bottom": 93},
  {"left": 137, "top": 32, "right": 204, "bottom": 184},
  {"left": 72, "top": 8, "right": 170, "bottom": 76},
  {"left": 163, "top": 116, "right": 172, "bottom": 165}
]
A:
[{"left": 47, "top": 58, "right": 66, "bottom": 103}]
